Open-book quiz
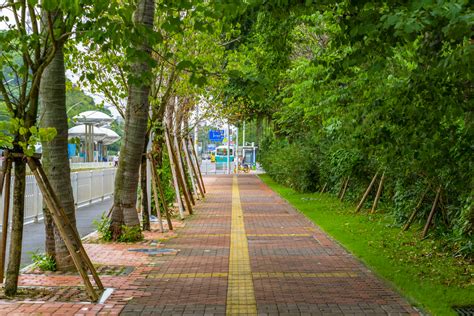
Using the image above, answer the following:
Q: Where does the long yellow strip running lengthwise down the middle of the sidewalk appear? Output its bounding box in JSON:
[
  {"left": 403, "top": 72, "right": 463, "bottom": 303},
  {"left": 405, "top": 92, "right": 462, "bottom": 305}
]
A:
[{"left": 226, "top": 176, "right": 257, "bottom": 315}]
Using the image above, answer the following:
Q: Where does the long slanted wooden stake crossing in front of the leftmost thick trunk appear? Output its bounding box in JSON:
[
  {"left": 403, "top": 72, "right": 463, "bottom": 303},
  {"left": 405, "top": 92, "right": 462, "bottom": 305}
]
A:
[{"left": 27, "top": 157, "right": 104, "bottom": 301}]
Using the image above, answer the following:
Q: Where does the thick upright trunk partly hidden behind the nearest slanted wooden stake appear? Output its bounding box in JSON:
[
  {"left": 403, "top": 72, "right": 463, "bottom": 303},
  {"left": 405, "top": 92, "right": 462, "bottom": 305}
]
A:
[{"left": 40, "top": 46, "right": 77, "bottom": 271}]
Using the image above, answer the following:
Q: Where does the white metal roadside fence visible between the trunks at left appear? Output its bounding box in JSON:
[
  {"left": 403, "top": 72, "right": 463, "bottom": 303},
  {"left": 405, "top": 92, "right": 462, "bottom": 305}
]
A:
[{"left": 0, "top": 168, "right": 116, "bottom": 227}]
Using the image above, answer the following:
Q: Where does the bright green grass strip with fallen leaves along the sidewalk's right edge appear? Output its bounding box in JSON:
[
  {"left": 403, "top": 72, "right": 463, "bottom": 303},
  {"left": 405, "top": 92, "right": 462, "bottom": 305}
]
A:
[{"left": 260, "top": 174, "right": 474, "bottom": 315}]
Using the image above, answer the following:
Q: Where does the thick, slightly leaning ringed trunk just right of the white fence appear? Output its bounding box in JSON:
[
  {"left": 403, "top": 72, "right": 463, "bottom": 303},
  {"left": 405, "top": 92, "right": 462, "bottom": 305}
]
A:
[{"left": 110, "top": 0, "right": 155, "bottom": 240}]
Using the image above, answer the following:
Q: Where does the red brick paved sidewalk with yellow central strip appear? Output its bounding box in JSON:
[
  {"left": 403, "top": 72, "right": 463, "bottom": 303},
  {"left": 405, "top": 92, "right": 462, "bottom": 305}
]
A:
[{"left": 0, "top": 175, "right": 417, "bottom": 315}]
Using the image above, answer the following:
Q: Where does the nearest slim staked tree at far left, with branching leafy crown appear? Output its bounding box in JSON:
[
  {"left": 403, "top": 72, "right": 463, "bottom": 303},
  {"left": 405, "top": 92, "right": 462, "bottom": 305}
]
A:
[{"left": 0, "top": 1, "right": 80, "bottom": 295}]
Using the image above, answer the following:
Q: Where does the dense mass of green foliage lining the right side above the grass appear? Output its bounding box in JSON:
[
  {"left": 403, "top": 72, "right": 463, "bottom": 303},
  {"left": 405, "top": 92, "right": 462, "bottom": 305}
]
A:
[{"left": 225, "top": 1, "right": 474, "bottom": 247}]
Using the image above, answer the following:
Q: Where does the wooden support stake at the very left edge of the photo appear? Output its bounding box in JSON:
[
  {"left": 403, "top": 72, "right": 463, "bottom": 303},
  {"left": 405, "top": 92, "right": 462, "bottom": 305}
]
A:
[{"left": 0, "top": 154, "right": 12, "bottom": 283}]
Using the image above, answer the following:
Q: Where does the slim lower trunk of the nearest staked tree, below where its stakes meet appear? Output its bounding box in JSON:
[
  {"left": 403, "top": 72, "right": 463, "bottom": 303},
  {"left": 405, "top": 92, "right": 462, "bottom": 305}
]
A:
[{"left": 5, "top": 158, "right": 26, "bottom": 296}]
